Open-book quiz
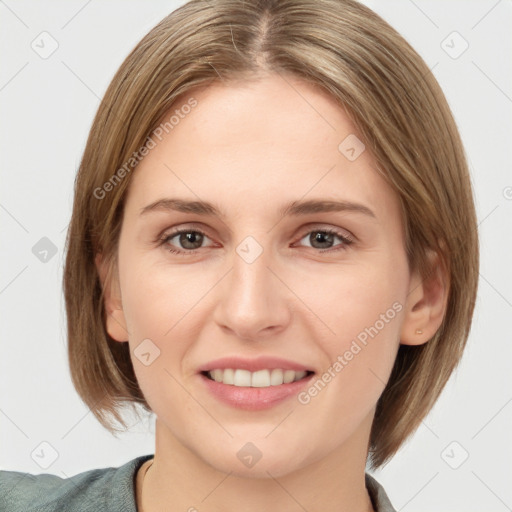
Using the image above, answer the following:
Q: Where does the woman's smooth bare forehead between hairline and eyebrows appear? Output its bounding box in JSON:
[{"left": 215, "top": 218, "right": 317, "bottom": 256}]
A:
[{"left": 123, "top": 75, "right": 398, "bottom": 224}]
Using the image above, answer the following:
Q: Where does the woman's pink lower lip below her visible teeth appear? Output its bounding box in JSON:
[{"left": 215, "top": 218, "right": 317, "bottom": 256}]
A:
[{"left": 199, "top": 373, "right": 314, "bottom": 411}]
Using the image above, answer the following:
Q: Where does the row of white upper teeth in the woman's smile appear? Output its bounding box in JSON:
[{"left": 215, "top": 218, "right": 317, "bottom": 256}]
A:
[{"left": 208, "top": 368, "right": 306, "bottom": 388}]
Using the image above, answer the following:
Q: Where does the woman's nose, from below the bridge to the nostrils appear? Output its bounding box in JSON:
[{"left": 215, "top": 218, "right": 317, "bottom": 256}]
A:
[{"left": 214, "top": 242, "right": 293, "bottom": 341}]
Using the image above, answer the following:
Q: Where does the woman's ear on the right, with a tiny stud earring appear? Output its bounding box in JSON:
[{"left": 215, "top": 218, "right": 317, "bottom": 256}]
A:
[{"left": 400, "top": 251, "right": 449, "bottom": 345}]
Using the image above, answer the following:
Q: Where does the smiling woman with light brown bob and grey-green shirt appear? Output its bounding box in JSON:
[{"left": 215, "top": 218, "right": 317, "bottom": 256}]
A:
[{"left": 0, "top": 0, "right": 478, "bottom": 512}]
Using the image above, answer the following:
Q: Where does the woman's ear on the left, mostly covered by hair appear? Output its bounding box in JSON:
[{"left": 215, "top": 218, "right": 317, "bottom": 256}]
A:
[{"left": 94, "top": 253, "right": 128, "bottom": 342}]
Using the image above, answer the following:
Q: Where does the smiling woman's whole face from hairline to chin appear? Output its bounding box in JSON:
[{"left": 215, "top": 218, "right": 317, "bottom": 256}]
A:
[{"left": 101, "top": 76, "right": 424, "bottom": 477}]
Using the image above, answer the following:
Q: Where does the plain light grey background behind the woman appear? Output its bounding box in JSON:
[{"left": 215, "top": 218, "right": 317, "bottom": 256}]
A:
[{"left": 0, "top": 0, "right": 512, "bottom": 512}]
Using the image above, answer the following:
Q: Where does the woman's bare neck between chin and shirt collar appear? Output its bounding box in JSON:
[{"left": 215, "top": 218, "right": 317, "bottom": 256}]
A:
[{"left": 137, "top": 418, "right": 373, "bottom": 512}]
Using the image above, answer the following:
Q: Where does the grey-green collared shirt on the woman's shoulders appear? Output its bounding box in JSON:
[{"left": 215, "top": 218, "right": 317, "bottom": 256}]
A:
[{"left": 0, "top": 454, "right": 396, "bottom": 512}]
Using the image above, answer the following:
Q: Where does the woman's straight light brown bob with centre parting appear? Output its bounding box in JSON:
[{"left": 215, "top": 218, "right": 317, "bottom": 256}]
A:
[{"left": 63, "top": 0, "right": 479, "bottom": 469}]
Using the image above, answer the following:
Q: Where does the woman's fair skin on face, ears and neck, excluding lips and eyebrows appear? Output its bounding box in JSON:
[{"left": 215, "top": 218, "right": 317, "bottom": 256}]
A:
[{"left": 96, "top": 75, "right": 447, "bottom": 512}]
